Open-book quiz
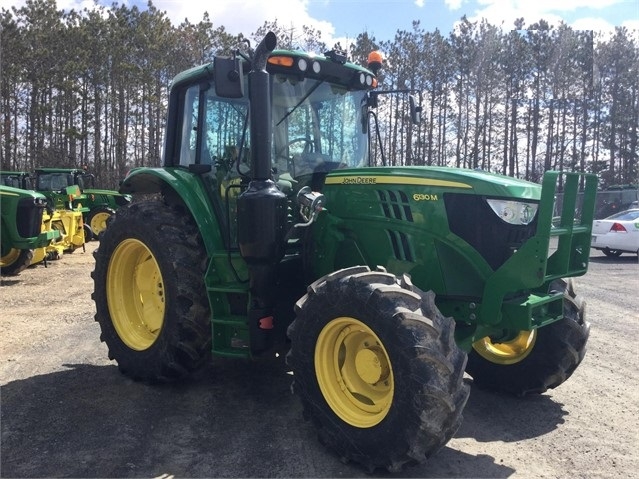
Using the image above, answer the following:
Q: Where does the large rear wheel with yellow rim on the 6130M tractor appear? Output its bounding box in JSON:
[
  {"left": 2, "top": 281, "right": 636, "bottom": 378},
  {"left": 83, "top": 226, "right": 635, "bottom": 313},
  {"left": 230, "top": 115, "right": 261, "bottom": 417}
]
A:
[{"left": 92, "top": 201, "right": 211, "bottom": 382}]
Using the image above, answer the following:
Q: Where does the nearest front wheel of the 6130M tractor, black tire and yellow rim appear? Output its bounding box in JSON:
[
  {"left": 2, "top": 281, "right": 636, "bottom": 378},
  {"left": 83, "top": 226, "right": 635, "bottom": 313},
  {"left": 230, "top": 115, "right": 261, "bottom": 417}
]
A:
[{"left": 287, "top": 267, "right": 469, "bottom": 472}]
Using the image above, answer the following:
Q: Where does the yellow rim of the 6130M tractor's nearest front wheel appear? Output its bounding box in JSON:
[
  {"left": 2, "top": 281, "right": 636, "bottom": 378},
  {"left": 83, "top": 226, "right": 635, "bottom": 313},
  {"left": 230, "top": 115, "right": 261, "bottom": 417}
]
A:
[{"left": 315, "top": 317, "right": 394, "bottom": 428}]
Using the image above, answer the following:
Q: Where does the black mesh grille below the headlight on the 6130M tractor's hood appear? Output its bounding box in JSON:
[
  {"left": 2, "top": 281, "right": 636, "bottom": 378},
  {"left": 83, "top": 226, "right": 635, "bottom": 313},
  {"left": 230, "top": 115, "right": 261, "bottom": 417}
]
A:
[{"left": 444, "top": 193, "right": 537, "bottom": 269}]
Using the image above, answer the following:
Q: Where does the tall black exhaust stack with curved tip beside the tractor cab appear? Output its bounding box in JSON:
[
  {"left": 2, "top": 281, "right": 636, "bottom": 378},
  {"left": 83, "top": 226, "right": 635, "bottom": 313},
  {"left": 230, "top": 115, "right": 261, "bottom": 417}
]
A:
[{"left": 237, "top": 32, "right": 287, "bottom": 353}]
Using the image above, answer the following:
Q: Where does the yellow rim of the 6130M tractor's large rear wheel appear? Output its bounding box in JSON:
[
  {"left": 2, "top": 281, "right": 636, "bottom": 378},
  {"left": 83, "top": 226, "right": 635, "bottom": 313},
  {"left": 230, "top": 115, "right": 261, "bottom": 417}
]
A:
[{"left": 107, "top": 239, "right": 165, "bottom": 351}]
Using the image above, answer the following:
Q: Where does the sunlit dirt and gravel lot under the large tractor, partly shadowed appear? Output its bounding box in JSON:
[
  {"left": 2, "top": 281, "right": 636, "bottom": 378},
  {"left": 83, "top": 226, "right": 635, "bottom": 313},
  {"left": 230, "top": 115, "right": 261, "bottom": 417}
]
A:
[{"left": 0, "top": 242, "right": 639, "bottom": 478}]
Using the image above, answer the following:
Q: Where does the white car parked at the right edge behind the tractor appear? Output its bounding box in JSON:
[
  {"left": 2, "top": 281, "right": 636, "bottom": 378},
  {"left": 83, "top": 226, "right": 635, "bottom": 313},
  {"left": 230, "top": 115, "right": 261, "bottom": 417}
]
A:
[{"left": 590, "top": 208, "right": 639, "bottom": 256}]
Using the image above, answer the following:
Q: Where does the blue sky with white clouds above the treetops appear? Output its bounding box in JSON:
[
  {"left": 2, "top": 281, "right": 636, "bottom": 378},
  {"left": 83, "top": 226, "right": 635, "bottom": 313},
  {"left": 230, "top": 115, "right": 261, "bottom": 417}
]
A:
[{"left": 0, "top": 0, "right": 639, "bottom": 46}]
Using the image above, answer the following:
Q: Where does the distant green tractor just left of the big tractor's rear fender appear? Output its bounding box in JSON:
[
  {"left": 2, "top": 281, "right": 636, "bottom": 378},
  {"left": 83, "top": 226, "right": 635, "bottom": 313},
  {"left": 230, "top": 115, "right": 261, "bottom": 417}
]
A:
[{"left": 35, "top": 168, "right": 131, "bottom": 241}]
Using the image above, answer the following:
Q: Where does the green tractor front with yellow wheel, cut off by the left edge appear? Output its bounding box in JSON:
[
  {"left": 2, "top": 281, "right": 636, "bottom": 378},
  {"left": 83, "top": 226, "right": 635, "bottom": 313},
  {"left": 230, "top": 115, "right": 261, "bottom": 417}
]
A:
[{"left": 0, "top": 186, "right": 60, "bottom": 276}]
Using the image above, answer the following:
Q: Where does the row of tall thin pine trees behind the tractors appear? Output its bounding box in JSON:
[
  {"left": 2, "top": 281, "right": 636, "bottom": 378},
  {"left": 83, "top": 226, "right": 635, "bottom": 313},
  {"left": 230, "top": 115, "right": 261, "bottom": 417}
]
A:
[{"left": 0, "top": 0, "right": 639, "bottom": 191}]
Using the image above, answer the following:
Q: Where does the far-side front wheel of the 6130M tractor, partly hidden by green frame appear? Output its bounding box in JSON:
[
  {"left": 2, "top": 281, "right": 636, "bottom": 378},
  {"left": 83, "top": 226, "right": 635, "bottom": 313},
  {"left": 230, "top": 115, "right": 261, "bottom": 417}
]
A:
[{"left": 466, "top": 280, "right": 590, "bottom": 396}]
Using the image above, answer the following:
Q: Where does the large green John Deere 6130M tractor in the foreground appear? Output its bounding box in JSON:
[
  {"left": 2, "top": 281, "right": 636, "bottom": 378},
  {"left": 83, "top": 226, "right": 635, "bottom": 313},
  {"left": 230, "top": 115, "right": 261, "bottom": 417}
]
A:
[{"left": 93, "top": 33, "right": 596, "bottom": 471}]
